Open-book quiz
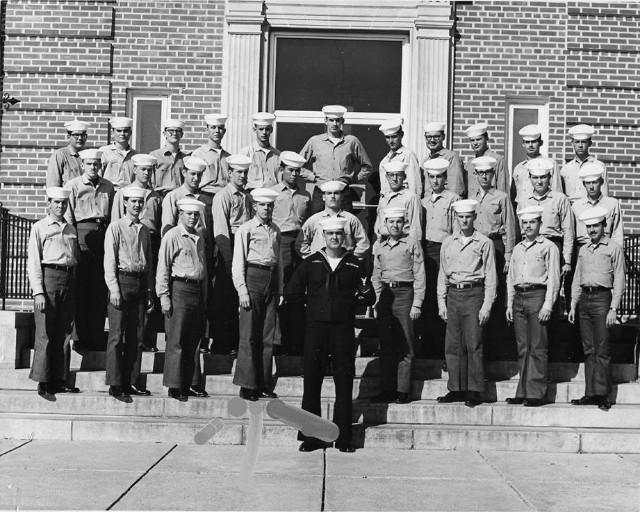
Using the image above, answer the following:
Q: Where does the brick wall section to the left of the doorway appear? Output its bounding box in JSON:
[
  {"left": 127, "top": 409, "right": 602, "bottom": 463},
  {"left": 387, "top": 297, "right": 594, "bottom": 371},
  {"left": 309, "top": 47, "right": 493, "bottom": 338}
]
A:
[{"left": 0, "top": 0, "right": 224, "bottom": 218}]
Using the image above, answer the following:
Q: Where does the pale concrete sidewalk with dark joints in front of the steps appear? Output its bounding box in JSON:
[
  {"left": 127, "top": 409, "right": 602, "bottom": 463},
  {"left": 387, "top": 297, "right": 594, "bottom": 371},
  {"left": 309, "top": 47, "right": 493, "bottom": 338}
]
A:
[{"left": 0, "top": 440, "right": 640, "bottom": 512}]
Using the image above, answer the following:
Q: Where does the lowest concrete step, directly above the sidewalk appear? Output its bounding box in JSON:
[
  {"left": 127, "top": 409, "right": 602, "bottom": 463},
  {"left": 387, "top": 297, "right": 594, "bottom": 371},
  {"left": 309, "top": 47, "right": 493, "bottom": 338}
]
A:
[{"left": 0, "top": 413, "right": 640, "bottom": 453}]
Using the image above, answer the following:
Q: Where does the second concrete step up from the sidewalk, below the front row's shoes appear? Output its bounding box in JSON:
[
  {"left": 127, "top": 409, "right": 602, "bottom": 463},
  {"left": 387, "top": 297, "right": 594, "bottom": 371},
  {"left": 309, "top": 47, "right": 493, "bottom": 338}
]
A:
[{"left": 0, "top": 390, "right": 640, "bottom": 429}]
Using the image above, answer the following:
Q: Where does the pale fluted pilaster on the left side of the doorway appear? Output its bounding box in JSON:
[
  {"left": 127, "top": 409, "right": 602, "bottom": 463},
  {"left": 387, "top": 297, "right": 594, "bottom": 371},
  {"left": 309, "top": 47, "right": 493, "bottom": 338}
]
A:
[{"left": 222, "top": 0, "right": 264, "bottom": 152}]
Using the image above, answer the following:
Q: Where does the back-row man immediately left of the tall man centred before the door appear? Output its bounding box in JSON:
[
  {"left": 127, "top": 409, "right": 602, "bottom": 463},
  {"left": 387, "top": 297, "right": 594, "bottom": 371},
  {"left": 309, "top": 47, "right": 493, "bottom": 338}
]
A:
[{"left": 238, "top": 112, "right": 280, "bottom": 191}]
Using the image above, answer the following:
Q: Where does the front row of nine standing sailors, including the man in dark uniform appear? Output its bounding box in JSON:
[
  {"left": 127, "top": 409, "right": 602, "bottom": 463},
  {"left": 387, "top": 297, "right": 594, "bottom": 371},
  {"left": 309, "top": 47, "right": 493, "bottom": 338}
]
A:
[{"left": 28, "top": 186, "right": 625, "bottom": 451}]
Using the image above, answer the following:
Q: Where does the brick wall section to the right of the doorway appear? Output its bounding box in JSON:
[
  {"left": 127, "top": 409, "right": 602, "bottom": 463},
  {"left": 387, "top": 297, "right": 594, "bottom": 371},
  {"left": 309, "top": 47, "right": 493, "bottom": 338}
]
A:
[{"left": 452, "top": 1, "right": 640, "bottom": 233}]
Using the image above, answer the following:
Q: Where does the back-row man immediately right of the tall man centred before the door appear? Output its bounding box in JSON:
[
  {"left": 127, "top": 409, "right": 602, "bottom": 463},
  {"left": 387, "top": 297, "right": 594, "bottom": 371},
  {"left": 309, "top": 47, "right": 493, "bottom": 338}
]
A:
[{"left": 378, "top": 118, "right": 422, "bottom": 197}]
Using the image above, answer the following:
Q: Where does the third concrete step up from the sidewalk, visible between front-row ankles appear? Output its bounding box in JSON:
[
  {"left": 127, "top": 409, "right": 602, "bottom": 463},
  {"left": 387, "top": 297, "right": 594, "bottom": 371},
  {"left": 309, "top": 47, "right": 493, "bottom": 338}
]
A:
[{"left": 0, "top": 368, "right": 640, "bottom": 404}]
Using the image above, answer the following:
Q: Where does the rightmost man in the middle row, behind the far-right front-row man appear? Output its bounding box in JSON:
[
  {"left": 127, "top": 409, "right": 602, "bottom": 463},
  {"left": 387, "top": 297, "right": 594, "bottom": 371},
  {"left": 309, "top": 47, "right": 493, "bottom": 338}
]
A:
[{"left": 572, "top": 161, "right": 624, "bottom": 246}]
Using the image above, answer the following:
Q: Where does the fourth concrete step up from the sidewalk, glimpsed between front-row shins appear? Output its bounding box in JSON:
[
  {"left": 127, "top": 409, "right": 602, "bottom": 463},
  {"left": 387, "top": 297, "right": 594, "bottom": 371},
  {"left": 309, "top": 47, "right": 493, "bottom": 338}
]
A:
[{"left": 15, "top": 350, "right": 638, "bottom": 383}]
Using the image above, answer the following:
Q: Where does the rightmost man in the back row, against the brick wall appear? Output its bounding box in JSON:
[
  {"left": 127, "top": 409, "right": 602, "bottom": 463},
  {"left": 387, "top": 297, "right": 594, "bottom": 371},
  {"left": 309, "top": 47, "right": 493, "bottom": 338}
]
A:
[{"left": 560, "top": 124, "right": 609, "bottom": 204}]
